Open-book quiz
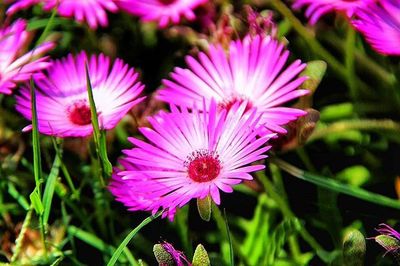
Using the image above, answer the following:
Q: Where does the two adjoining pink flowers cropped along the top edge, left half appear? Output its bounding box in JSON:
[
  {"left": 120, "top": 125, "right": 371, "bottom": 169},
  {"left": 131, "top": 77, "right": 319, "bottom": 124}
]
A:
[{"left": 5, "top": 0, "right": 207, "bottom": 29}]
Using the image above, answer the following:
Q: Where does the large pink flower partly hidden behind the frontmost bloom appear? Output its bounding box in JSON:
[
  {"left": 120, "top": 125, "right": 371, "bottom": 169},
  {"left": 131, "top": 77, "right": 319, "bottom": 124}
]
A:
[{"left": 158, "top": 35, "right": 308, "bottom": 133}]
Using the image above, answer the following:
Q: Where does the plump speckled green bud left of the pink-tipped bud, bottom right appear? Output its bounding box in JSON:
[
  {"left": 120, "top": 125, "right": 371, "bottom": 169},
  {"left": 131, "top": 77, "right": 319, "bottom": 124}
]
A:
[{"left": 343, "top": 229, "right": 366, "bottom": 266}]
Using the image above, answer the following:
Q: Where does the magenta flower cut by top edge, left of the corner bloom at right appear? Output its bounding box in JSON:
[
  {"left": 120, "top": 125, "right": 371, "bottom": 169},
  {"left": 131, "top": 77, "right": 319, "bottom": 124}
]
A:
[{"left": 293, "top": 0, "right": 377, "bottom": 25}]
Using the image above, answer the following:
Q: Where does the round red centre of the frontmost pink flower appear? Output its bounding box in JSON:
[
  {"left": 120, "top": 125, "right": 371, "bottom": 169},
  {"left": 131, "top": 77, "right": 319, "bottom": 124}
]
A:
[{"left": 185, "top": 150, "right": 221, "bottom": 183}]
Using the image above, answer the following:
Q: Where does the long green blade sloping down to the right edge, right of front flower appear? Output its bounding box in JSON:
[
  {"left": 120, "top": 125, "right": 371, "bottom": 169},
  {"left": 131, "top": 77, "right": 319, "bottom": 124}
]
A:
[{"left": 270, "top": 158, "right": 400, "bottom": 210}]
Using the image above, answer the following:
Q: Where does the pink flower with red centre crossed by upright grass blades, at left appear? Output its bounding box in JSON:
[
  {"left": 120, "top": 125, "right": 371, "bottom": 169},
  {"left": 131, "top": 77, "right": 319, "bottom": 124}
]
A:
[{"left": 16, "top": 52, "right": 144, "bottom": 137}]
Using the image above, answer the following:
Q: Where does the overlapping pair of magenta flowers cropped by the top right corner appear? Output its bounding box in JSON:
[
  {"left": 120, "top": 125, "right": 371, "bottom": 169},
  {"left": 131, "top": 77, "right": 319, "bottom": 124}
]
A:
[{"left": 293, "top": 0, "right": 400, "bottom": 55}]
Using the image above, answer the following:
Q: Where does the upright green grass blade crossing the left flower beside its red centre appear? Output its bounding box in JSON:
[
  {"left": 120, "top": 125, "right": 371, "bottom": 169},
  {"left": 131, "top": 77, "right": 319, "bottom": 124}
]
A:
[{"left": 85, "top": 64, "right": 112, "bottom": 177}]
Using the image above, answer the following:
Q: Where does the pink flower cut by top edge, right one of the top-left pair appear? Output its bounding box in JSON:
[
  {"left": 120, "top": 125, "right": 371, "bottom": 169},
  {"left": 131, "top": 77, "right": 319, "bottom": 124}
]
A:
[{"left": 115, "top": 0, "right": 207, "bottom": 28}]
